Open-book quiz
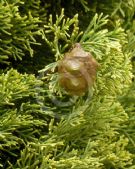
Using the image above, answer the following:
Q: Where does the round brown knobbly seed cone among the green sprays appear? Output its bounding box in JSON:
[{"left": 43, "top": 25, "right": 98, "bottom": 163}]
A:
[{"left": 58, "top": 43, "right": 99, "bottom": 95}]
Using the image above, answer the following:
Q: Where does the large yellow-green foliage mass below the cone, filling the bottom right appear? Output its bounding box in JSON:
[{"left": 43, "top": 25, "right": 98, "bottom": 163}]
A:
[{"left": 5, "top": 98, "right": 132, "bottom": 169}]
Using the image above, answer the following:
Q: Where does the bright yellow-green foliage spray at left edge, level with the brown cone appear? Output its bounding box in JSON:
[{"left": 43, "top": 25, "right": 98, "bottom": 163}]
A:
[{"left": 0, "top": 69, "right": 41, "bottom": 106}]
